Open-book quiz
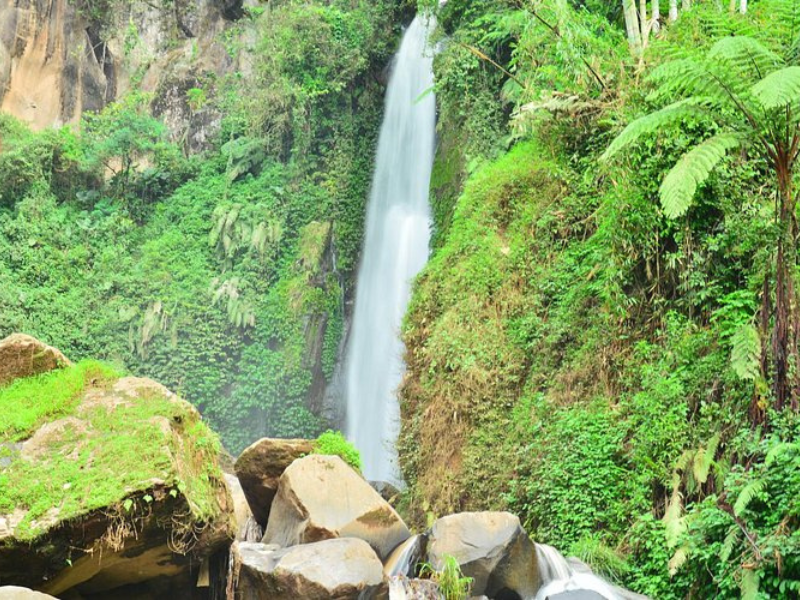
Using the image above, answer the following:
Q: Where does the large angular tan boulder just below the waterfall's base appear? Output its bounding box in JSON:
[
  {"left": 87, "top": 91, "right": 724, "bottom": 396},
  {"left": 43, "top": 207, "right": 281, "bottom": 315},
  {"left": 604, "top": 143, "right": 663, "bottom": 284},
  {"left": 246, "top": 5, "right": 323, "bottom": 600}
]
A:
[{"left": 262, "top": 454, "right": 411, "bottom": 560}]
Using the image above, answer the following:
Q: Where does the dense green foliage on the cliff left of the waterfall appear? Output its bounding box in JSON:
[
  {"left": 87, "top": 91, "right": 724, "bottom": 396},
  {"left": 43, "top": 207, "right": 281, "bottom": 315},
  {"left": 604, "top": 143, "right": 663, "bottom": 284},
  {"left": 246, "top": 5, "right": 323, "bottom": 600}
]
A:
[{"left": 0, "top": 0, "right": 404, "bottom": 452}]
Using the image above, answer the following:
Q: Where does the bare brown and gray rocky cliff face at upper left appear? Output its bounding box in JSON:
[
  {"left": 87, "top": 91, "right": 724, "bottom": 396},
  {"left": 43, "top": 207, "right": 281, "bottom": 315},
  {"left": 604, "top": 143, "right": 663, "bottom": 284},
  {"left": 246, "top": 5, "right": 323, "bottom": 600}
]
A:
[{"left": 0, "top": 0, "right": 246, "bottom": 147}]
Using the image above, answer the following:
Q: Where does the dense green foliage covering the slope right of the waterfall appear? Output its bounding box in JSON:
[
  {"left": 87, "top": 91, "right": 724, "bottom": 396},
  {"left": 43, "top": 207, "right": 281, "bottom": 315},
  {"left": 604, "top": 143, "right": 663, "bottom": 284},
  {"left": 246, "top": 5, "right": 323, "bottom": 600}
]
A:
[{"left": 400, "top": 0, "right": 800, "bottom": 598}]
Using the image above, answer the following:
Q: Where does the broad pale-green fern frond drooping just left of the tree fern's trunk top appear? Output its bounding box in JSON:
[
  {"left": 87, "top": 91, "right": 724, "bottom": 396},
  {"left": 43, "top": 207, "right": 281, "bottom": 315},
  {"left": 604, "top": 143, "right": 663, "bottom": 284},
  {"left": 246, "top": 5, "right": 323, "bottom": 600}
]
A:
[{"left": 659, "top": 133, "right": 742, "bottom": 219}]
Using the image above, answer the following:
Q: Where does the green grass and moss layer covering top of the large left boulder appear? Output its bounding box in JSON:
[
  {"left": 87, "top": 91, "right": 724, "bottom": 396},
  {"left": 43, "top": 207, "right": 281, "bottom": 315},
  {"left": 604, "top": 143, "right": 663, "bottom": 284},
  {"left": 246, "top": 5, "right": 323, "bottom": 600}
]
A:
[{"left": 0, "top": 362, "right": 227, "bottom": 541}]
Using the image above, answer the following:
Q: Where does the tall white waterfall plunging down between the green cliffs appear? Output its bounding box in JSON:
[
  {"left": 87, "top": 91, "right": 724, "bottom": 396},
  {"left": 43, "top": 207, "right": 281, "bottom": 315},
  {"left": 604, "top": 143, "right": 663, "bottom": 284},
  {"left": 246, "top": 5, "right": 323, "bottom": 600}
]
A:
[{"left": 345, "top": 16, "right": 436, "bottom": 483}]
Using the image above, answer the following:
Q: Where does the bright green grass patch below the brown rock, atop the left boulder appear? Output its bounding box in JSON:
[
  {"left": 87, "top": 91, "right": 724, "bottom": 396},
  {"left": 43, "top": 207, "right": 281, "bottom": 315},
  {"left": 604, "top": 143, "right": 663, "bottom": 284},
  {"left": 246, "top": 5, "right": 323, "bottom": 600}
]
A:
[{"left": 0, "top": 360, "right": 120, "bottom": 441}]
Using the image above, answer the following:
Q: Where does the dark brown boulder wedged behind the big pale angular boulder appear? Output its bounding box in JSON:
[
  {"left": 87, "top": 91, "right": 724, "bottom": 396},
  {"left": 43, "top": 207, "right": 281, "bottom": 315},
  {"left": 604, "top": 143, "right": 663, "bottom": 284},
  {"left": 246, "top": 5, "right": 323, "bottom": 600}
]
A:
[{"left": 233, "top": 438, "right": 313, "bottom": 527}]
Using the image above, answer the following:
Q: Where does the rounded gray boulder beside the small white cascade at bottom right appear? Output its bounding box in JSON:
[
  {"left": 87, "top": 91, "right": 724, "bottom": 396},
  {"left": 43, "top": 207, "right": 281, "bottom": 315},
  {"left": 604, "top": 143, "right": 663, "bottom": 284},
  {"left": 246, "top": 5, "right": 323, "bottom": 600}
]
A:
[{"left": 428, "top": 512, "right": 541, "bottom": 598}]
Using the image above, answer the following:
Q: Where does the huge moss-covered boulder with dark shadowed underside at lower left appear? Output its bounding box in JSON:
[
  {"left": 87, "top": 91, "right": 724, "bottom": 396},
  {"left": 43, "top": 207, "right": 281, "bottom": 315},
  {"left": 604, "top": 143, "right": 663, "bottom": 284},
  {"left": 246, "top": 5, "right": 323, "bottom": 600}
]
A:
[{"left": 0, "top": 338, "right": 233, "bottom": 597}]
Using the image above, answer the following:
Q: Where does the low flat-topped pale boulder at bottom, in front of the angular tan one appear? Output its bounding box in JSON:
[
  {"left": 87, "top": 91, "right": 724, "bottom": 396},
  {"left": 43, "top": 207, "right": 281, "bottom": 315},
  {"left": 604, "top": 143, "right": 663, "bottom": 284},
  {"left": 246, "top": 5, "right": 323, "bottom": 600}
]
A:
[{"left": 234, "top": 538, "right": 384, "bottom": 600}]
